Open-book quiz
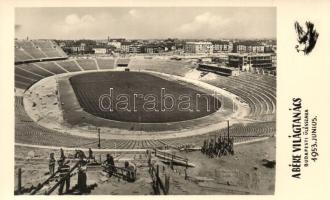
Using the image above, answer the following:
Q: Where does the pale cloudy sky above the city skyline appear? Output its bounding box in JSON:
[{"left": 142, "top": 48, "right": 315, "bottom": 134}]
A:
[{"left": 15, "top": 7, "right": 276, "bottom": 39}]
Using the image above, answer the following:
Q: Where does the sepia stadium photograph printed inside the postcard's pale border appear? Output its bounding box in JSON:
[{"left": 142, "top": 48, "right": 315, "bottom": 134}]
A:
[{"left": 13, "top": 6, "right": 278, "bottom": 195}]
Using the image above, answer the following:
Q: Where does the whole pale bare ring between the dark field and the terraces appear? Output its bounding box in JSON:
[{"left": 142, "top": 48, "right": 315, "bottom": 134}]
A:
[{"left": 23, "top": 66, "right": 253, "bottom": 140}]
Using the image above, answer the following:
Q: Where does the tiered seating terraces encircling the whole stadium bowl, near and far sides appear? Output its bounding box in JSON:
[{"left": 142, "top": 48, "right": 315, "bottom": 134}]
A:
[{"left": 15, "top": 56, "right": 276, "bottom": 149}]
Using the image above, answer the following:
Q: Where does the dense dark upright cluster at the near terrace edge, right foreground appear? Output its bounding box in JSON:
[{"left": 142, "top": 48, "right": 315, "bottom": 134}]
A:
[{"left": 201, "top": 135, "right": 234, "bottom": 158}]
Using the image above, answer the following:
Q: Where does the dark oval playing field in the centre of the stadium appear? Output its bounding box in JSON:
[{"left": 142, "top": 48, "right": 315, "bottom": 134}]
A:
[{"left": 70, "top": 72, "right": 221, "bottom": 123}]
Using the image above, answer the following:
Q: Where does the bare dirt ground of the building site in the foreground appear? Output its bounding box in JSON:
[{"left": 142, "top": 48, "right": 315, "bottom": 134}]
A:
[{"left": 15, "top": 137, "right": 276, "bottom": 195}]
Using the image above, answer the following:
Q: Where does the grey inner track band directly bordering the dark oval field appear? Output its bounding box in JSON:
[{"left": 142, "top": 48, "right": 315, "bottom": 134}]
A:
[{"left": 58, "top": 71, "right": 244, "bottom": 132}]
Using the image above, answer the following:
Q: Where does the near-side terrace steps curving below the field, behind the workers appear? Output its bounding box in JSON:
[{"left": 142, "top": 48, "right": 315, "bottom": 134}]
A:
[{"left": 15, "top": 96, "right": 276, "bottom": 149}]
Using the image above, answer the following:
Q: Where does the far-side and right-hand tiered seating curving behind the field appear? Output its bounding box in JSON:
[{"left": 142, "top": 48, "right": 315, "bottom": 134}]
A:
[{"left": 15, "top": 59, "right": 276, "bottom": 119}]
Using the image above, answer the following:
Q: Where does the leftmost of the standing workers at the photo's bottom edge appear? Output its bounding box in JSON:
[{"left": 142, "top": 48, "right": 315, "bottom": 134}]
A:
[{"left": 58, "top": 159, "right": 70, "bottom": 195}]
